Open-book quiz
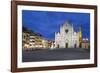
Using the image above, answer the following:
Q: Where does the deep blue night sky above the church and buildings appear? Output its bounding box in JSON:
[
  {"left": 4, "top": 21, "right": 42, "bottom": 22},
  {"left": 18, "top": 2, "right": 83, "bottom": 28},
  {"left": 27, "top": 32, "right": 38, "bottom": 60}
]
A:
[{"left": 22, "top": 10, "right": 90, "bottom": 40}]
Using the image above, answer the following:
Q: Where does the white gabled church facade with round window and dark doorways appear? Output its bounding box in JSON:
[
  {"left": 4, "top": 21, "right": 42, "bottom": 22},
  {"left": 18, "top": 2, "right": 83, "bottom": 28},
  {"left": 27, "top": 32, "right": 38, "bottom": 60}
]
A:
[{"left": 55, "top": 22, "right": 82, "bottom": 48}]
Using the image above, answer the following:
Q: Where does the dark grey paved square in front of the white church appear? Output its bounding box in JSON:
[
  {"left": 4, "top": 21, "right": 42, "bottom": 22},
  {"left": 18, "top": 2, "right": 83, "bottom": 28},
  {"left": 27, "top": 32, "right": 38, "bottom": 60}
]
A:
[{"left": 22, "top": 48, "right": 90, "bottom": 62}]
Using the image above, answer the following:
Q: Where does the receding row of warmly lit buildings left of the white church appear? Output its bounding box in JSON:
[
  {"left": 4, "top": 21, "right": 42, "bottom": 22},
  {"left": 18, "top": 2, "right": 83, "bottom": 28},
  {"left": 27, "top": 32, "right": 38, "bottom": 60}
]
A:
[{"left": 22, "top": 27, "right": 48, "bottom": 50}]
